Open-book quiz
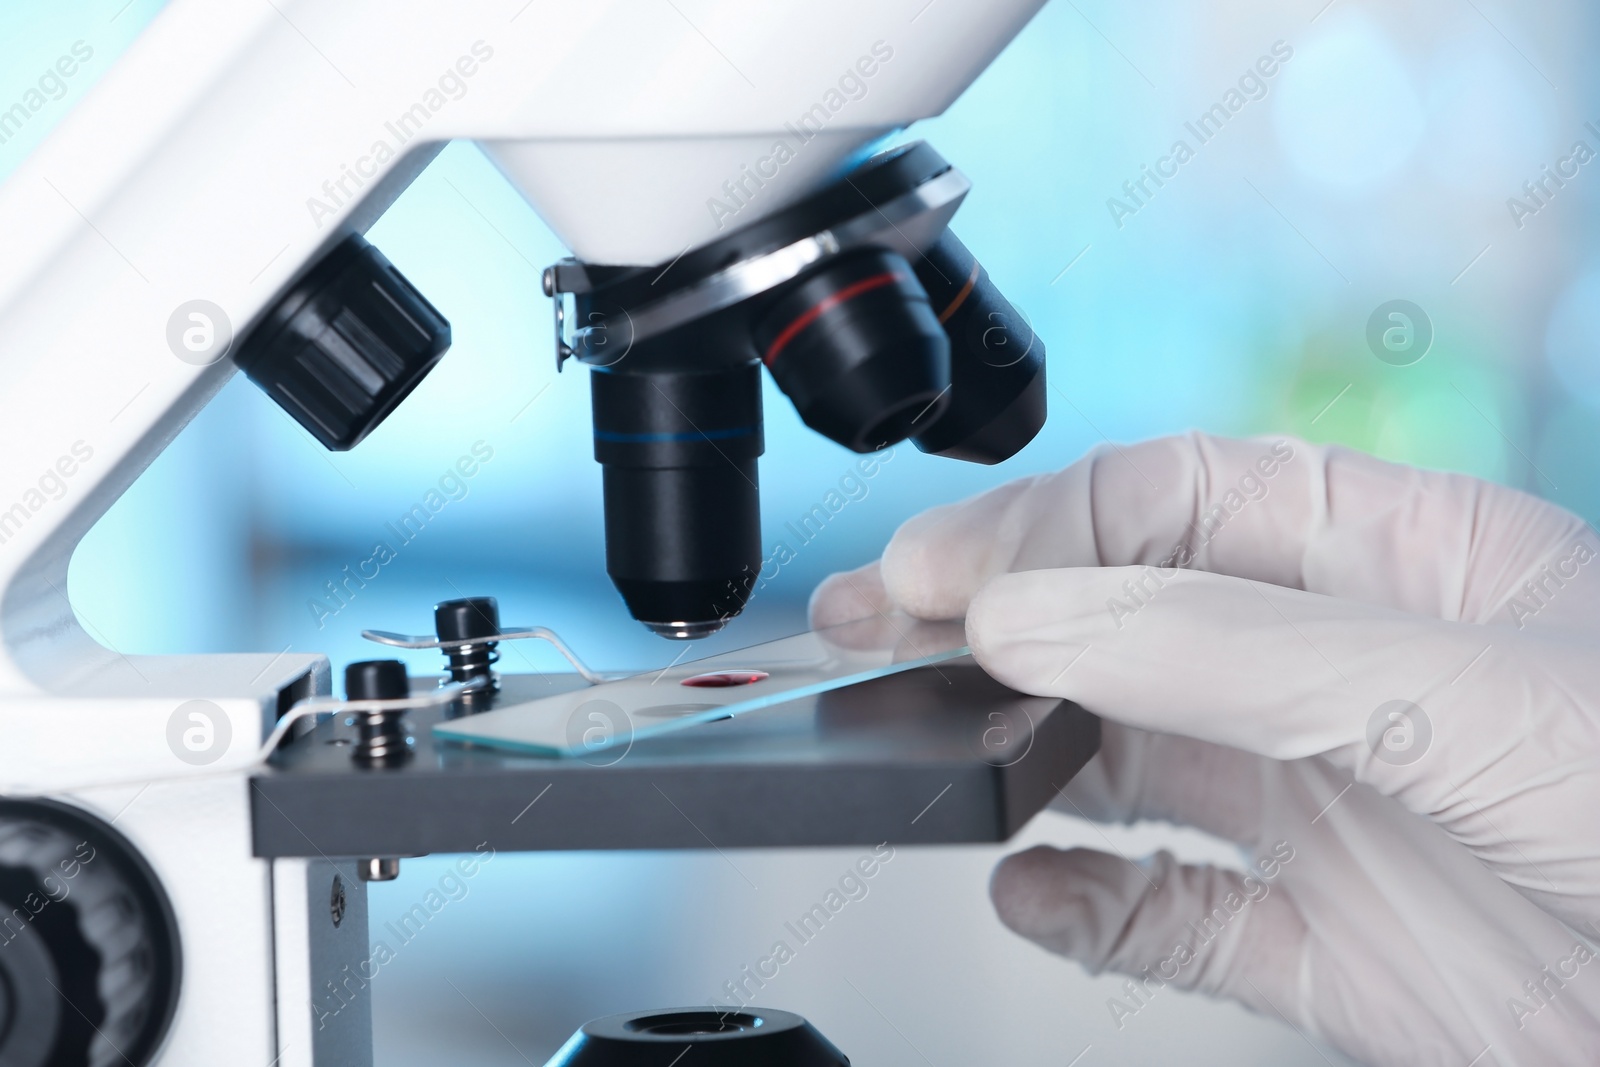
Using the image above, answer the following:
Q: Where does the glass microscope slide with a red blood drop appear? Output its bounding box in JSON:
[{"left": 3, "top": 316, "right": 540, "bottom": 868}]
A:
[{"left": 434, "top": 614, "right": 968, "bottom": 761}]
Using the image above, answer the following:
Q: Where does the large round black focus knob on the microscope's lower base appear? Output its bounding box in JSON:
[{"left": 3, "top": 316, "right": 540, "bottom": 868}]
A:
[{"left": 0, "top": 798, "right": 182, "bottom": 1067}]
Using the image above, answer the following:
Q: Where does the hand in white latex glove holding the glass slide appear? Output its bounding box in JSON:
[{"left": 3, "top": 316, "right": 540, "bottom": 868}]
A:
[{"left": 811, "top": 435, "right": 1600, "bottom": 1067}]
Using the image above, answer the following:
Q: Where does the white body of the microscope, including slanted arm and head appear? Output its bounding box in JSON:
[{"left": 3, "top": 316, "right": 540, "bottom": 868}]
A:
[{"left": 0, "top": 0, "right": 1043, "bottom": 1067}]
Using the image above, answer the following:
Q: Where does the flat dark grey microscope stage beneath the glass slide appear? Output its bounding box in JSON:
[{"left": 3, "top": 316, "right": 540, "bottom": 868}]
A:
[{"left": 251, "top": 668, "right": 1099, "bottom": 857}]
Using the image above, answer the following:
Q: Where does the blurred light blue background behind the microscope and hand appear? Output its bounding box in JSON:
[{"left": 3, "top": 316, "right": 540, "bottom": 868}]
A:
[{"left": 0, "top": 0, "right": 1600, "bottom": 1064}]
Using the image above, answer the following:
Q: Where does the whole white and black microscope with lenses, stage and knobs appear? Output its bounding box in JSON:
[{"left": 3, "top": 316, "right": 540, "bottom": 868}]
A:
[{"left": 0, "top": 0, "right": 1099, "bottom": 1067}]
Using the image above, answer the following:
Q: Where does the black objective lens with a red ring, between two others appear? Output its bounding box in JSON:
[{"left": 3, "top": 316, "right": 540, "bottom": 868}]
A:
[{"left": 755, "top": 251, "right": 950, "bottom": 453}]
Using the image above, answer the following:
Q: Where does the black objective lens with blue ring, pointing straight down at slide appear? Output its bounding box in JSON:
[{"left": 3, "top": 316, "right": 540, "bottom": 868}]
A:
[{"left": 589, "top": 363, "right": 765, "bottom": 640}]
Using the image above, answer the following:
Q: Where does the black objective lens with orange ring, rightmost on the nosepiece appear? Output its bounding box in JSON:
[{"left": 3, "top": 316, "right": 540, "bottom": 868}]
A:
[{"left": 914, "top": 230, "right": 1046, "bottom": 464}]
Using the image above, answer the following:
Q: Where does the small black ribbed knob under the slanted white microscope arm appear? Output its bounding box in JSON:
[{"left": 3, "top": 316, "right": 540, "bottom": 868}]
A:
[{"left": 237, "top": 234, "right": 450, "bottom": 451}]
